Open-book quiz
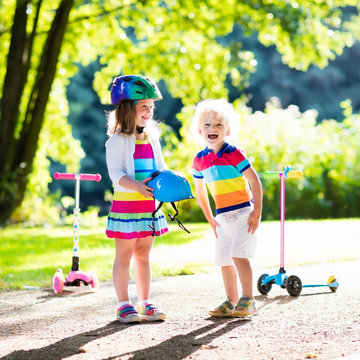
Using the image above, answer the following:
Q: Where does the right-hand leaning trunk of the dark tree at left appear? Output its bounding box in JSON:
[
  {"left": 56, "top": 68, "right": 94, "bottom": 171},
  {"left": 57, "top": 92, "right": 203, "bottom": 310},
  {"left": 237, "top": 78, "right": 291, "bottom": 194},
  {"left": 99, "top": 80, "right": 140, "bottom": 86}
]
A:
[{"left": 0, "top": 0, "right": 74, "bottom": 223}]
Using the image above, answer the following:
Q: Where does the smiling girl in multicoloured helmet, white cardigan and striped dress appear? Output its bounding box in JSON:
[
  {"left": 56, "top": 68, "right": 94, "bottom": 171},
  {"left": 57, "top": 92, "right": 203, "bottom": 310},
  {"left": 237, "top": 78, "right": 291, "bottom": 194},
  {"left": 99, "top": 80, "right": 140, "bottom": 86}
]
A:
[{"left": 106, "top": 75, "right": 168, "bottom": 323}]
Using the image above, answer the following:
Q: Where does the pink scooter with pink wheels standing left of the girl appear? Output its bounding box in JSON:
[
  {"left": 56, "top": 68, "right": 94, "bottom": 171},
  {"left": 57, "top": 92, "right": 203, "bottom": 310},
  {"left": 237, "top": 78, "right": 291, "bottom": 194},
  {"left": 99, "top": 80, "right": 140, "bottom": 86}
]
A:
[{"left": 53, "top": 172, "right": 101, "bottom": 294}]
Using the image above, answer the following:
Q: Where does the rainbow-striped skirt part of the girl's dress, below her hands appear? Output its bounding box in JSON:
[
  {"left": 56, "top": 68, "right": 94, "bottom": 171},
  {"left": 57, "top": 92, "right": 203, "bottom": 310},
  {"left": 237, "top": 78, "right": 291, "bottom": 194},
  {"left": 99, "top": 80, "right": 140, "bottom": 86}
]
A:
[{"left": 106, "top": 191, "right": 168, "bottom": 239}]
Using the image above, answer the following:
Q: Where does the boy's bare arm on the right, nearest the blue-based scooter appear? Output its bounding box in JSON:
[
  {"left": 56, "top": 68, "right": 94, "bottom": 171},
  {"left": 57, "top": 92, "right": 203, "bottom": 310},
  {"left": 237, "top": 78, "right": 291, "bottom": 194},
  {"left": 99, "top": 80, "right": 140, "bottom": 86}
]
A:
[{"left": 243, "top": 166, "right": 262, "bottom": 234}]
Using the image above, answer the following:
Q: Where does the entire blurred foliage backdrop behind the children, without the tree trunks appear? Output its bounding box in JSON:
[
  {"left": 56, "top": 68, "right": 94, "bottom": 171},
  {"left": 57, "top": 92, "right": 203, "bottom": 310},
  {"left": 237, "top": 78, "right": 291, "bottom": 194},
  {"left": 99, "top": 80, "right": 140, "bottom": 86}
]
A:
[{"left": 0, "top": 0, "right": 360, "bottom": 225}]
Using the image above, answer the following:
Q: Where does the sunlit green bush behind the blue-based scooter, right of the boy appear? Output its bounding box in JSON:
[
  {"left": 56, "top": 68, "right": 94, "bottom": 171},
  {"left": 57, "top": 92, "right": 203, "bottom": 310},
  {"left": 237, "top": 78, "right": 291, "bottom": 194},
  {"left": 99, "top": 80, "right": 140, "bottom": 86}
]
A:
[{"left": 235, "top": 99, "right": 360, "bottom": 219}]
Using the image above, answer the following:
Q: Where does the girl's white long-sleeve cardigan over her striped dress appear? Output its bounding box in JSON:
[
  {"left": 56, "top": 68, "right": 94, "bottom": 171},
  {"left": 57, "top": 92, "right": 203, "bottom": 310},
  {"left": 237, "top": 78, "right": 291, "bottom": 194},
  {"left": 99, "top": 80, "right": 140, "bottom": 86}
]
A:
[{"left": 105, "top": 134, "right": 166, "bottom": 192}]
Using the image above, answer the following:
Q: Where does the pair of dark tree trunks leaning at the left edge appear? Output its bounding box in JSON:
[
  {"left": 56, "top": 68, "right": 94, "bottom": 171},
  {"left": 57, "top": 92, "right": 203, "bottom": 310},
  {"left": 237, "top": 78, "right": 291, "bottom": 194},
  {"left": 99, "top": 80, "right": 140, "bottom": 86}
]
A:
[{"left": 0, "top": 0, "right": 74, "bottom": 220}]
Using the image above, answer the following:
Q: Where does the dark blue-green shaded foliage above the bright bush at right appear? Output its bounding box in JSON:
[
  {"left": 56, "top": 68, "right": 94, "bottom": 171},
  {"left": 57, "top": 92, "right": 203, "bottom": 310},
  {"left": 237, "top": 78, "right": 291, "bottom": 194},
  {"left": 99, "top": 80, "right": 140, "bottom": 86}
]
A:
[{"left": 233, "top": 29, "right": 360, "bottom": 122}]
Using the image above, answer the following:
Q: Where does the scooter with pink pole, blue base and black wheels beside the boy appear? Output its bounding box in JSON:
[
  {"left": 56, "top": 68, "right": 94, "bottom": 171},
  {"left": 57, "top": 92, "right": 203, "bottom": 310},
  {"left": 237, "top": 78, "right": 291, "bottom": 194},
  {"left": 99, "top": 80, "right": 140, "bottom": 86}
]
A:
[{"left": 257, "top": 165, "right": 339, "bottom": 296}]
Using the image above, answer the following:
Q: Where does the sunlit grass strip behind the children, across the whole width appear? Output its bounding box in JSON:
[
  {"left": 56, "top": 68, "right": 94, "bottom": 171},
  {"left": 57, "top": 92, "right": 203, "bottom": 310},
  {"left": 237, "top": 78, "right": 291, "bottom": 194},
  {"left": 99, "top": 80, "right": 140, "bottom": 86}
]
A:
[{"left": 0, "top": 218, "right": 360, "bottom": 291}]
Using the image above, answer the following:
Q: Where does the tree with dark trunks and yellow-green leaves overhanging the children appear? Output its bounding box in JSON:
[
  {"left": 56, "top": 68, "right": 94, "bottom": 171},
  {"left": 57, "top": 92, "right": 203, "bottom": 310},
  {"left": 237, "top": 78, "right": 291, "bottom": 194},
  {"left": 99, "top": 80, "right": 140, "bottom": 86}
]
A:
[{"left": 0, "top": 0, "right": 358, "bottom": 222}]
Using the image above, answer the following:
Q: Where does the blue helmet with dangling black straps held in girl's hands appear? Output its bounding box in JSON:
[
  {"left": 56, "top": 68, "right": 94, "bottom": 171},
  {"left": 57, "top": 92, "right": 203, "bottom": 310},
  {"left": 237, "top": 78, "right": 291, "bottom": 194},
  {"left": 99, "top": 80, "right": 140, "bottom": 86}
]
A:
[{"left": 147, "top": 170, "right": 195, "bottom": 235}]
